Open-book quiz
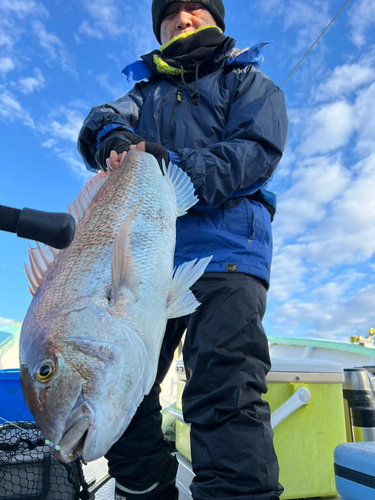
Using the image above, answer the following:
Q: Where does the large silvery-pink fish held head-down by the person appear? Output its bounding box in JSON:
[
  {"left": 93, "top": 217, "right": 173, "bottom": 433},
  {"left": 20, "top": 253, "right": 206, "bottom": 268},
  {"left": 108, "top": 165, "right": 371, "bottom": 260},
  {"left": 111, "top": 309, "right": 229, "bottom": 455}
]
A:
[{"left": 20, "top": 151, "right": 210, "bottom": 462}]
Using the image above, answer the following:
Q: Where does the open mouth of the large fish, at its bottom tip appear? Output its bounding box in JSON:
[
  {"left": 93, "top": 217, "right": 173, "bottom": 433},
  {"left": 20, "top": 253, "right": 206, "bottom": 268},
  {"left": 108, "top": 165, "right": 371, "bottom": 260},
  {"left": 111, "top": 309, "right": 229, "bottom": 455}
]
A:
[{"left": 55, "top": 417, "right": 95, "bottom": 463}]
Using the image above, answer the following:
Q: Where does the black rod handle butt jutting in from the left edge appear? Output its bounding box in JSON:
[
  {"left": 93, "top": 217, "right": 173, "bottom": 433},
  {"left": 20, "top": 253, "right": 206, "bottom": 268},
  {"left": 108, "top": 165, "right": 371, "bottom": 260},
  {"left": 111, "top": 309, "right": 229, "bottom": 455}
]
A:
[{"left": 0, "top": 205, "right": 76, "bottom": 250}]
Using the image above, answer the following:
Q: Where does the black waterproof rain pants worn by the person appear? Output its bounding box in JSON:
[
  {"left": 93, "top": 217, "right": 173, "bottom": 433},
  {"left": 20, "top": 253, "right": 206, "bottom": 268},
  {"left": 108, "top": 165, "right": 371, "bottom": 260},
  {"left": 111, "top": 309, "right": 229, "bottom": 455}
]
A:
[{"left": 106, "top": 273, "right": 283, "bottom": 500}]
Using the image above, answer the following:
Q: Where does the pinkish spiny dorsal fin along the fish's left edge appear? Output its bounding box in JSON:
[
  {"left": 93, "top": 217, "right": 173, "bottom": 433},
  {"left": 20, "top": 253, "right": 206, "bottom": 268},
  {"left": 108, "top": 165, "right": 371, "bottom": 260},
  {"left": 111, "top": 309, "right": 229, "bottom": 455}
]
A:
[{"left": 25, "top": 172, "right": 110, "bottom": 296}]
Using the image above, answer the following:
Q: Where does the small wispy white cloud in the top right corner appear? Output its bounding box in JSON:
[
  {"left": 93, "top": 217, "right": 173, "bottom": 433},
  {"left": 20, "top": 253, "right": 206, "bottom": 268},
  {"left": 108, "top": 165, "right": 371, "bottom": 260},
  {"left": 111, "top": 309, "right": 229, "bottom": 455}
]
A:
[{"left": 348, "top": 0, "right": 375, "bottom": 48}]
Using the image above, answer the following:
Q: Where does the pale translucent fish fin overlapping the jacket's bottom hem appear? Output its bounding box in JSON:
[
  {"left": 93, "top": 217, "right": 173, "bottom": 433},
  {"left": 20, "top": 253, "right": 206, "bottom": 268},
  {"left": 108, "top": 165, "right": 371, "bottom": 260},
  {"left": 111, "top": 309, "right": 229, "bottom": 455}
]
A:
[{"left": 167, "top": 255, "right": 212, "bottom": 319}]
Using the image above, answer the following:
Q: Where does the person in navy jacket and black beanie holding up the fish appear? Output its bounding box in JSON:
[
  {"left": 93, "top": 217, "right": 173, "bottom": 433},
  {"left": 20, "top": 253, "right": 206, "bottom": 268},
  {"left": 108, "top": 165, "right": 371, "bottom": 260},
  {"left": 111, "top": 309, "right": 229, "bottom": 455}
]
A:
[{"left": 78, "top": 0, "right": 288, "bottom": 500}]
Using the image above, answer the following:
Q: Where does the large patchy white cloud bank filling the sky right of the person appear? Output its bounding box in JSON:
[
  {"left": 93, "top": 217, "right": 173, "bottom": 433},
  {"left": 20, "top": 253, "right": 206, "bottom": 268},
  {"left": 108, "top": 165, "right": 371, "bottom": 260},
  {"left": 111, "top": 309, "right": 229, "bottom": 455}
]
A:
[{"left": 269, "top": 51, "right": 375, "bottom": 320}]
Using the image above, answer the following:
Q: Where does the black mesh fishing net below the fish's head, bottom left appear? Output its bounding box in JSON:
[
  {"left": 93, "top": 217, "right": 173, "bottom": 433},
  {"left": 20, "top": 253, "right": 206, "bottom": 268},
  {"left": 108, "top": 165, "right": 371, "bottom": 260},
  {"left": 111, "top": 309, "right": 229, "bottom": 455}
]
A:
[{"left": 0, "top": 422, "right": 90, "bottom": 500}]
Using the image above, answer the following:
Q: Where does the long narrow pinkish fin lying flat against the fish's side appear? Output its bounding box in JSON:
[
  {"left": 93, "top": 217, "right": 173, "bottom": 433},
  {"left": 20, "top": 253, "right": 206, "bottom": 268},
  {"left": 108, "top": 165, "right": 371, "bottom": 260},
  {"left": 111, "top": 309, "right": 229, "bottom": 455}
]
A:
[{"left": 112, "top": 201, "right": 142, "bottom": 298}]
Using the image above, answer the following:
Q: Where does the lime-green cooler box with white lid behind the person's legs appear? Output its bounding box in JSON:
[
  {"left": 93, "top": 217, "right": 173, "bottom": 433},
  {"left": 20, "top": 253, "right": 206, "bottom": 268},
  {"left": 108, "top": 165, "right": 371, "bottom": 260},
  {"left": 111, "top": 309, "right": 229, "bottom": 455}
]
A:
[{"left": 176, "top": 359, "right": 346, "bottom": 500}]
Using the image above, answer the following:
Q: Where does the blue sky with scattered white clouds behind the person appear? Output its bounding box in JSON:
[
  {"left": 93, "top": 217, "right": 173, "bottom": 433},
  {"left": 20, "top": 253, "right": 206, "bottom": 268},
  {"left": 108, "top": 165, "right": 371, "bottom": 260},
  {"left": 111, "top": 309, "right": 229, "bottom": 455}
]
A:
[{"left": 0, "top": 0, "right": 375, "bottom": 340}]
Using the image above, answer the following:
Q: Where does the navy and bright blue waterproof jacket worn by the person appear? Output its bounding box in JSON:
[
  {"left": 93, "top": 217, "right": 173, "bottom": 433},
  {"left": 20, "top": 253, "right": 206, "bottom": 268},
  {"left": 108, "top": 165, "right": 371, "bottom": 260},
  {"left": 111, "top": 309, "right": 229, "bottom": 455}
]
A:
[{"left": 78, "top": 37, "right": 288, "bottom": 285}]
